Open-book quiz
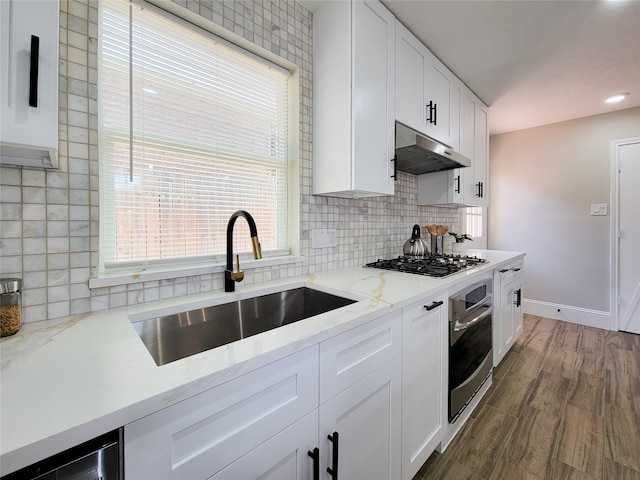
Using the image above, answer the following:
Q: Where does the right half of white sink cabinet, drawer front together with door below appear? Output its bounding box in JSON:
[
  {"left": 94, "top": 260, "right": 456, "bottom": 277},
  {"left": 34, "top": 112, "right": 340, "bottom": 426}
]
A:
[{"left": 319, "top": 312, "right": 402, "bottom": 480}]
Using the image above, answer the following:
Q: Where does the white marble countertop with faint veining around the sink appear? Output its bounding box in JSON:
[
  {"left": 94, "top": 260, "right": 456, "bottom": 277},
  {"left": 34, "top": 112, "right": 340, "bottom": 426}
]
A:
[{"left": 0, "top": 250, "right": 524, "bottom": 475}]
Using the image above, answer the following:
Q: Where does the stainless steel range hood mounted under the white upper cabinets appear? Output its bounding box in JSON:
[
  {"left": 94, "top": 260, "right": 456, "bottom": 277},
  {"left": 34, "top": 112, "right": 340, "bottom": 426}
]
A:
[{"left": 396, "top": 122, "right": 471, "bottom": 175}]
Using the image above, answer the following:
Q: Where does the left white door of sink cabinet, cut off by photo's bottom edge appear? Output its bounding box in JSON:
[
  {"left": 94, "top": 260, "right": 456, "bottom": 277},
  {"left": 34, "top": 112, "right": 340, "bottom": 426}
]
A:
[{"left": 210, "top": 410, "right": 320, "bottom": 480}]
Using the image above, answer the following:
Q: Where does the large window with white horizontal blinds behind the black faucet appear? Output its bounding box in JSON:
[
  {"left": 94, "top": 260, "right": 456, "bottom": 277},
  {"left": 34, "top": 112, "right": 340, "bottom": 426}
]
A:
[{"left": 100, "top": 1, "right": 289, "bottom": 271}]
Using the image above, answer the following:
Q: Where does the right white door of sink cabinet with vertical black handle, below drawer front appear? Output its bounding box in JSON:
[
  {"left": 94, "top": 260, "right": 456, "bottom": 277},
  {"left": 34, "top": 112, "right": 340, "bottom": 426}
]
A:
[{"left": 319, "top": 356, "right": 402, "bottom": 480}]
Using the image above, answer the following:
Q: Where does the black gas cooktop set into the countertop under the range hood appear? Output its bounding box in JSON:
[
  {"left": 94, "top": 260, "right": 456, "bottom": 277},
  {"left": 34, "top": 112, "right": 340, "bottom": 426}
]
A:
[{"left": 365, "top": 255, "right": 487, "bottom": 277}]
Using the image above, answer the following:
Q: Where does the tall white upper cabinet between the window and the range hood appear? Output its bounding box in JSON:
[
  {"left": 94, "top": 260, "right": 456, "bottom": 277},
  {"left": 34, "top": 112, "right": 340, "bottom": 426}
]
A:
[{"left": 313, "top": 0, "right": 396, "bottom": 197}]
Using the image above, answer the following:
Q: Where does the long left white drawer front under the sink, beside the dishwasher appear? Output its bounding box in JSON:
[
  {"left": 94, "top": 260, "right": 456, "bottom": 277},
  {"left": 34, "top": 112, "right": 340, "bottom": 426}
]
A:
[{"left": 125, "top": 347, "right": 318, "bottom": 480}]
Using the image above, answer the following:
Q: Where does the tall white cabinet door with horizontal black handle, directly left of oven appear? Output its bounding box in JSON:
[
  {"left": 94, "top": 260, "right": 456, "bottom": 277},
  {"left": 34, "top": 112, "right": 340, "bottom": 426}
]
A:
[{"left": 402, "top": 297, "right": 448, "bottom": 480}]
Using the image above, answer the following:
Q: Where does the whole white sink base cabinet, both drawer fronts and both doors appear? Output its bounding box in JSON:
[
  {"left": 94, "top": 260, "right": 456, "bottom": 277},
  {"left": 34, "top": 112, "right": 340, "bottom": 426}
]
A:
[{"left": 125, "top": 312, "right": 402, "bottom": 480}]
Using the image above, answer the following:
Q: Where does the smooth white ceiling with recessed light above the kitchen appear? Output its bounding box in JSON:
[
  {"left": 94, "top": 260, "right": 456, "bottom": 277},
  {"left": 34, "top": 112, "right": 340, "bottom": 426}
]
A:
[{"left": 301, "top": 0, "right": 640, "bottom": 135}]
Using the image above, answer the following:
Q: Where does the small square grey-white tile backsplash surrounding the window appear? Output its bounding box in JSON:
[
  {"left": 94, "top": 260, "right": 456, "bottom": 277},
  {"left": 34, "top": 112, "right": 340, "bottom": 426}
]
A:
[{"left": 0, "top": 0, "right": 459, "bottom": 322}]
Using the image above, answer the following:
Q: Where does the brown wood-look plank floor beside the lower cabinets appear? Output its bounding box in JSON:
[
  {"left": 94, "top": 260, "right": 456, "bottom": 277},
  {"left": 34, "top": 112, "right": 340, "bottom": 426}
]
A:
[{"left": 413, "top": 315, "right": 640, "bottom": 480}]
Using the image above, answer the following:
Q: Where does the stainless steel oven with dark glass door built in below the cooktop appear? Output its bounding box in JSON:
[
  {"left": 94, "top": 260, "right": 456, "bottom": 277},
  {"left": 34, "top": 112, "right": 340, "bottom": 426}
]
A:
[{"left": 449, "top": 278, "right": 493, "bottom": 423}]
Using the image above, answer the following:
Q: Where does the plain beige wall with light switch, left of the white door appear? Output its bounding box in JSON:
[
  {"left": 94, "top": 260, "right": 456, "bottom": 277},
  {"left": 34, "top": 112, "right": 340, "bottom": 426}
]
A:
[{"left": 488, "top": 108, "right": 640, "bottom": 312}]
